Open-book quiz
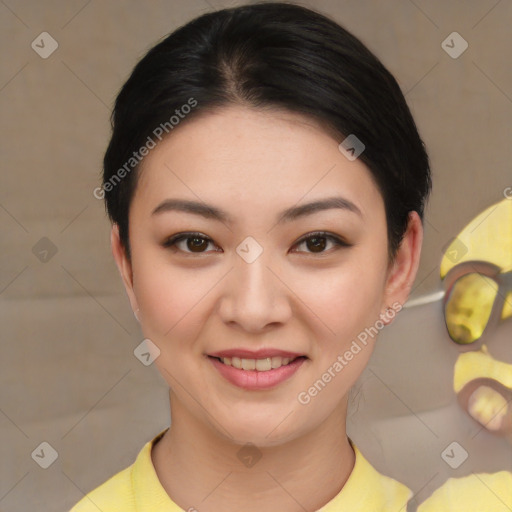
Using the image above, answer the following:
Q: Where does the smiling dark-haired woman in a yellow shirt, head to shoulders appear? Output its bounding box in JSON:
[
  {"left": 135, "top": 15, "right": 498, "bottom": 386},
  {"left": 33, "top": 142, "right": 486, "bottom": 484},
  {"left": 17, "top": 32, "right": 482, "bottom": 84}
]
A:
[{"left": 73, "top": 3, "right": 431, "bottom": 512}]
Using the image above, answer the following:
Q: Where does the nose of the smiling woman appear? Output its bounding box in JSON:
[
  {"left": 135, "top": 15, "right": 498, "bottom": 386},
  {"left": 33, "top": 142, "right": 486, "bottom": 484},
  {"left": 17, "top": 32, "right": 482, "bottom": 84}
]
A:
[{"left": 218, "top": 251, "right": 293, "bottom": 333}]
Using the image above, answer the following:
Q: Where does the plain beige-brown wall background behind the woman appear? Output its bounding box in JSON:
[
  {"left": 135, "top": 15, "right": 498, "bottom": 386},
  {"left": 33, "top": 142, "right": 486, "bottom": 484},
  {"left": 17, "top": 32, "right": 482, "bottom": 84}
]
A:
[{"left": 0, "top": 0, "right": 512, "bottom": 512}]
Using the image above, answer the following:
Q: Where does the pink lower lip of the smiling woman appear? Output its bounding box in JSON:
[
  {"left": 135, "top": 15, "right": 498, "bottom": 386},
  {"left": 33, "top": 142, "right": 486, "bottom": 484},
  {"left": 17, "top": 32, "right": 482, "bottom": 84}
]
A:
[{"left": 207, "top": 356, "right": 306, "bottom": 390}]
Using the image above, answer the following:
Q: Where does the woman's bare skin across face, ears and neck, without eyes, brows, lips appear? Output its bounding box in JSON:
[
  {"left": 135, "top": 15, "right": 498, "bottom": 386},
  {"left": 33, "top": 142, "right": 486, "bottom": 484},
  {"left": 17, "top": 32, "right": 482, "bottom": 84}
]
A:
[{"left": 111, "top": 106, "right": 423, "bottom": 512}]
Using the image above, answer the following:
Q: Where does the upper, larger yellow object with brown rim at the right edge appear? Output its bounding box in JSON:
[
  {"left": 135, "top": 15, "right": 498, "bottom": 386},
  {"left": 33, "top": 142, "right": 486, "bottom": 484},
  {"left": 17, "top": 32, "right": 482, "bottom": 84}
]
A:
[{"left": 440, "top": 199, "right": 512, "bottom": 350}]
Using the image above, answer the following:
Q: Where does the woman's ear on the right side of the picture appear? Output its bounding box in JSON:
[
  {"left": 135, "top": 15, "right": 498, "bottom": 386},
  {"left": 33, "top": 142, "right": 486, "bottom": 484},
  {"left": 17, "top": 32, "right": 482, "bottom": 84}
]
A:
[{"left": 381, "top": 211, "right": 423, "bottom": 324}]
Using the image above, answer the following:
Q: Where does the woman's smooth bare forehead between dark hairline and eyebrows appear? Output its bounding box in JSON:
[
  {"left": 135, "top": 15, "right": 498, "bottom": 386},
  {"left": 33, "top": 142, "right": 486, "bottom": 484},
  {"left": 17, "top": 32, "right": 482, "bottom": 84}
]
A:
[{"left": 132, "top": 106, "right": 383, "bottom": 221}]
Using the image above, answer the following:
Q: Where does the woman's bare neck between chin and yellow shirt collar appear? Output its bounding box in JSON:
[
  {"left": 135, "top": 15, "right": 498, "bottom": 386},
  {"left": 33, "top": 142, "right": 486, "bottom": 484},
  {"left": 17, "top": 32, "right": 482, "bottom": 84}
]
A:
[{"left": 152, "top": 394, "right": 355, "bottom": 512}]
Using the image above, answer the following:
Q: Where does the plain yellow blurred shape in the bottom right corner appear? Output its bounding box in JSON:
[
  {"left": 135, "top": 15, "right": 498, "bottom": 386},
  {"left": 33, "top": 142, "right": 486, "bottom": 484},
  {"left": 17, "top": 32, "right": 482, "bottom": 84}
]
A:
[{"left": 417, "top": 471, "right": 512, "bottom": 512}]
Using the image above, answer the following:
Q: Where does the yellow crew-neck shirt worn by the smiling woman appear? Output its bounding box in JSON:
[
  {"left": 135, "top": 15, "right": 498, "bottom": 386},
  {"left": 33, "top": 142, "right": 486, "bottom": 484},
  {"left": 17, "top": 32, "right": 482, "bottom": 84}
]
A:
[{"left": 70, "top": 429, "right": 413, "bottom": 512}]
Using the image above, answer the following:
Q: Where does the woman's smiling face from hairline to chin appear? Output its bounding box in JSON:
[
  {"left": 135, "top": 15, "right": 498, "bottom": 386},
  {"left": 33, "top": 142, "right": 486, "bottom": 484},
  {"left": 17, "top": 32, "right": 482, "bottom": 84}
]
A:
[{"left": 113, "top": 107, "right": 416, "bottom": 446}]
